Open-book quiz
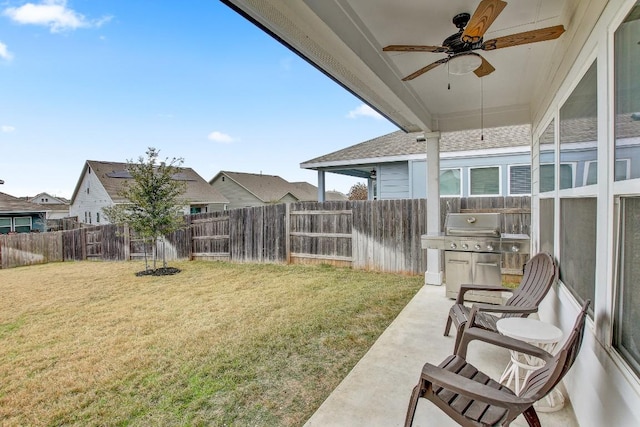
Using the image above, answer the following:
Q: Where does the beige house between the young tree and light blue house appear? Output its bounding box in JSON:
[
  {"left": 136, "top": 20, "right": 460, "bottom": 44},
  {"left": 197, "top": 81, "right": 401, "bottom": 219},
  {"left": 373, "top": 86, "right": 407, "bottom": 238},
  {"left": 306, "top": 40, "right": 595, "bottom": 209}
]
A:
[{"left": 209, "top": 171, "right": 336, "bottom": 209}]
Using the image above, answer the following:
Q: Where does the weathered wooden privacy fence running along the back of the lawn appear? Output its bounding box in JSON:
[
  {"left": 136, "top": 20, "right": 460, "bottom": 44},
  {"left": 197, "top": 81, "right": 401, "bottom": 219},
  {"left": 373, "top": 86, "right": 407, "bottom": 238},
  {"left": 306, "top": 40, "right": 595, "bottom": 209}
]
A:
[{"left": 0, "top": 197, "right": 531, "bottom": 274}]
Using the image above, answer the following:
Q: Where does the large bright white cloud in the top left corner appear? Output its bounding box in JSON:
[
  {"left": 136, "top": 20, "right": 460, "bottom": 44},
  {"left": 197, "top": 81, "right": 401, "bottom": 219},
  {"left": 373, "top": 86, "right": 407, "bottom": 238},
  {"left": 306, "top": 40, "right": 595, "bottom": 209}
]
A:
[{"left": 2, "top": 0, "right": 111, "bottom": 33}]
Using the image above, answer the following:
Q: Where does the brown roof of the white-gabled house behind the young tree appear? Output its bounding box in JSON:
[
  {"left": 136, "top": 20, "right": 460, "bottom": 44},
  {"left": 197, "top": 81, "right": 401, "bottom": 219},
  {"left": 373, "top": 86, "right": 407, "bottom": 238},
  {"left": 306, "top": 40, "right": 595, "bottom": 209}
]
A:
[{"left": 71, "top": 160, "right": 229, "bottom": 204}]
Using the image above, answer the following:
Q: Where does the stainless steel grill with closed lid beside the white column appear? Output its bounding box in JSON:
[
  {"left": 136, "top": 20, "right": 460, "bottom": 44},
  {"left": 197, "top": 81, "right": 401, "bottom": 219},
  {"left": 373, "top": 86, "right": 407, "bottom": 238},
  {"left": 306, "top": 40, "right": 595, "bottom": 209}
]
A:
[{"left": 422, "top": 213, "right": 529, "bottom": 303}]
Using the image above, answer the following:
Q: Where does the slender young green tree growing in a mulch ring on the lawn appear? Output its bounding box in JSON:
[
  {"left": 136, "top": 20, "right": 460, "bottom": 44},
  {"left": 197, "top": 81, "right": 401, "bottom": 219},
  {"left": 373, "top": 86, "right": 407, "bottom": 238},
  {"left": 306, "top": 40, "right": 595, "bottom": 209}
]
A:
[{"left": 103, "top": 147, "right": 186, "bottom": 270}]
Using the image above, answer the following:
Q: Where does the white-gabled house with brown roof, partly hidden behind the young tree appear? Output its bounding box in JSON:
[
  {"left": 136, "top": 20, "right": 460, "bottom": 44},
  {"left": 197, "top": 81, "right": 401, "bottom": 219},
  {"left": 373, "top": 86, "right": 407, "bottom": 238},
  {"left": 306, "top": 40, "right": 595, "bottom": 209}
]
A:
[{"left": 69, "top": 160, "right": 228, "bottom": 224}]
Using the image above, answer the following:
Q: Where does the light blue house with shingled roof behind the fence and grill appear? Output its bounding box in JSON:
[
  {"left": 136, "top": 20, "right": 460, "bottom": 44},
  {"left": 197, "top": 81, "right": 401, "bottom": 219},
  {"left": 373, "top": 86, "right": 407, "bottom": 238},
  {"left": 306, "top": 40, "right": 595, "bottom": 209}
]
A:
[{"left": 300, "top": 125, "right": 531, "bottom": 200}]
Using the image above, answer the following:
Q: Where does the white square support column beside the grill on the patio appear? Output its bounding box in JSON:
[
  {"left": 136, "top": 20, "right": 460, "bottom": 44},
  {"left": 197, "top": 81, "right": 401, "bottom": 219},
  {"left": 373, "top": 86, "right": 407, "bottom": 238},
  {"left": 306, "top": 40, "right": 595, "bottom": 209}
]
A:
[{"left": 424, "top": 132, "right": 442, "bottom": 286}]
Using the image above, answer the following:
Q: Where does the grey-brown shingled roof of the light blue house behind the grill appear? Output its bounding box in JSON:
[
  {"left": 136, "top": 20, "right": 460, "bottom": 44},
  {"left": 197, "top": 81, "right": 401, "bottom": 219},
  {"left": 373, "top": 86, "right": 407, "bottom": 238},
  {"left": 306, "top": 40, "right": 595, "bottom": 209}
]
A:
[{"left": 300, "top": 125, "right": 531, "bottom": 168}]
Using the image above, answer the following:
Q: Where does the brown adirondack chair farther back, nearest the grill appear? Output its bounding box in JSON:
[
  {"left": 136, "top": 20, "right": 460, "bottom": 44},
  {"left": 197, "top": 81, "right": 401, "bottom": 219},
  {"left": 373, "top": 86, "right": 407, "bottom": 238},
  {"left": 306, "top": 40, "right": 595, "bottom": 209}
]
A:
[{"left": 444, "top": 252, "right": 558, "bottom": 353}]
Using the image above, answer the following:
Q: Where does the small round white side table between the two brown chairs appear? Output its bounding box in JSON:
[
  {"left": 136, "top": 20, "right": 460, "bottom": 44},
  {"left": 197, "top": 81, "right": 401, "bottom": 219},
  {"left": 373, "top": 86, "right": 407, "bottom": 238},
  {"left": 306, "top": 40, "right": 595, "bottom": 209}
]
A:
[{"left": 496, "top": 317, "right": 564, "bottom": 412}]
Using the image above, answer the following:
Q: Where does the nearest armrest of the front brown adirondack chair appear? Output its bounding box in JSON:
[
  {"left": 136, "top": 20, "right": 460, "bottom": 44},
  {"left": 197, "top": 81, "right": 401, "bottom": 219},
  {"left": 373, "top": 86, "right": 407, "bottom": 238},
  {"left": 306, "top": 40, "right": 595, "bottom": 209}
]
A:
[{"left": 422, "top": 363, "right": 532, "bottom": 408}]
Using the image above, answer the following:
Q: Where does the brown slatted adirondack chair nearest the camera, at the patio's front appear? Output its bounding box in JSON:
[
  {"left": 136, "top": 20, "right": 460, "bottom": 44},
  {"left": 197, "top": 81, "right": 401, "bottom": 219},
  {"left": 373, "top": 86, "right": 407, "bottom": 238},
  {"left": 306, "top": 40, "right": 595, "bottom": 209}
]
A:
[{"left": 405, "top": 301, "right": 590, "bottom": 427}]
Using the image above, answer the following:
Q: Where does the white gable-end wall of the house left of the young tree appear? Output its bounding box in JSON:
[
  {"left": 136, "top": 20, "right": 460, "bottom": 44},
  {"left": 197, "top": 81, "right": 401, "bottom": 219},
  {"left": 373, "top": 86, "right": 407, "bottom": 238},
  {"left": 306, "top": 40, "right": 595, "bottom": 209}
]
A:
[{"left": 69, "top": 168, "right": 113, "bottom": 225}]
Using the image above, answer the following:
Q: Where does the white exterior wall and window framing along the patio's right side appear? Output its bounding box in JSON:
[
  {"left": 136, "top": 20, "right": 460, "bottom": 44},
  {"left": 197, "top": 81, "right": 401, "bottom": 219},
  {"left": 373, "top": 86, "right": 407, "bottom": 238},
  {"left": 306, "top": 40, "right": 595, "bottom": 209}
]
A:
[{"left": 531, "top": 0, "right": 640, "bottom": 427}]
